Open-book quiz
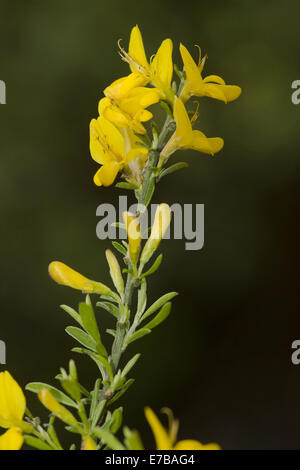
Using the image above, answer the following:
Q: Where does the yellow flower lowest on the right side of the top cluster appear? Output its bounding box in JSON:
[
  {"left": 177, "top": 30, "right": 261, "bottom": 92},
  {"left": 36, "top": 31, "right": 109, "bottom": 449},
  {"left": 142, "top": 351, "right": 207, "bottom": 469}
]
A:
[{"left": 161, "top": 98, "right": 224, "bottom": 161}]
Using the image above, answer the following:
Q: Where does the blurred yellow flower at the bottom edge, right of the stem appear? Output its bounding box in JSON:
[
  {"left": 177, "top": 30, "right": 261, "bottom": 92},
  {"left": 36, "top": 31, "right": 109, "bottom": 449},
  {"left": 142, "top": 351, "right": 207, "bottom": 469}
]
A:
[{"left": 145, "top": 407, "right": 220, "bottom": 450}]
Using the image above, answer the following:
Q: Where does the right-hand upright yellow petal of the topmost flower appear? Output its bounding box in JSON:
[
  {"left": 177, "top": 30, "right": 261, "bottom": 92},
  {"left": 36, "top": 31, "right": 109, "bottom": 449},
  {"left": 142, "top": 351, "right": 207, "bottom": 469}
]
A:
[{"left": 151, "top": 39, "right": 173, "bottom": 89}]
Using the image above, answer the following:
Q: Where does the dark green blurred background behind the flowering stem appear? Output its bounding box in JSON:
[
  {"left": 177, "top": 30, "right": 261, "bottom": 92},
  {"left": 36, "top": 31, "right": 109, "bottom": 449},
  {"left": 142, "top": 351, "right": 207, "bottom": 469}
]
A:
[{"left": 0, "top": 0, "right": 300, "bottom": 449}]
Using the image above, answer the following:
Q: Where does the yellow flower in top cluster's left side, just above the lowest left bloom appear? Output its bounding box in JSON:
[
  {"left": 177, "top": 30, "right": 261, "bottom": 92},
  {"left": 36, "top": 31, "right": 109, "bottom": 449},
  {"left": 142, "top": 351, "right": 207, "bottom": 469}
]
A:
[{"left": 98, "top": 87, "right": 159, "bottom": 134}]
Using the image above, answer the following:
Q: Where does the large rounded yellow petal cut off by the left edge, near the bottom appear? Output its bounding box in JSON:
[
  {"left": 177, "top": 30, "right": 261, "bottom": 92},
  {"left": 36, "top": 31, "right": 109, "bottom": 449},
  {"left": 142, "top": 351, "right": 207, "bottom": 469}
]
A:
[{"left": 0, "top": 371, "right": 26, "bottom": 428}]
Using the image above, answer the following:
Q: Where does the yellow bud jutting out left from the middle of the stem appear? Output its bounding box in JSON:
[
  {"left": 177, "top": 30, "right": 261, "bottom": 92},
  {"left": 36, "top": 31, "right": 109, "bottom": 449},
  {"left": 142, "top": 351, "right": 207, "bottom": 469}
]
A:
[{"left": 48, "top": 261, "right": 112, "bottom": 295}]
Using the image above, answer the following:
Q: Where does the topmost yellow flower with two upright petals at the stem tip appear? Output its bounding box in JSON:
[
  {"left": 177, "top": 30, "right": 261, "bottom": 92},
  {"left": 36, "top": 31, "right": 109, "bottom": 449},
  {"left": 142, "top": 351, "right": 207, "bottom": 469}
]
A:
[{"left": 121, "top": 26, "right": 174, "bottom": 102}]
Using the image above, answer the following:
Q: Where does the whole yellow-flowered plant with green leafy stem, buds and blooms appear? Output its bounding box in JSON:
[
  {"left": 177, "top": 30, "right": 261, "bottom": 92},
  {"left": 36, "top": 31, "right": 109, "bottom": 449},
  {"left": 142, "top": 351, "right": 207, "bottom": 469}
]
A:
[{"left": 0, "top": 26, "right": 241, "bottom": 450}]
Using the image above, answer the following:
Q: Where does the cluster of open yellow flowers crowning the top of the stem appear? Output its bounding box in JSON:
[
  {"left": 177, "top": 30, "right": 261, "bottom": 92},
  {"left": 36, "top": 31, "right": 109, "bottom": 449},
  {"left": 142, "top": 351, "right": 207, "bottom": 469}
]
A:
[{"left": 90, "top": 26, "right": 241, "bottom": 189}]
